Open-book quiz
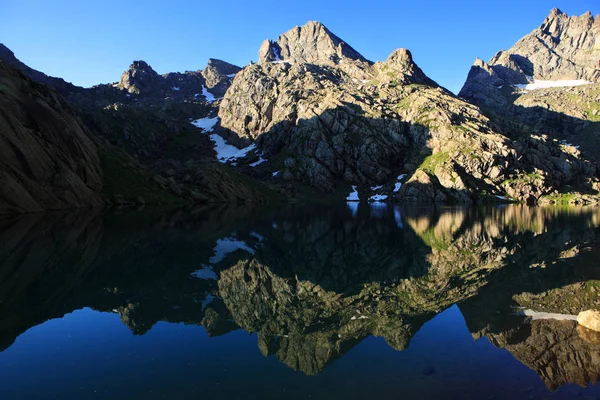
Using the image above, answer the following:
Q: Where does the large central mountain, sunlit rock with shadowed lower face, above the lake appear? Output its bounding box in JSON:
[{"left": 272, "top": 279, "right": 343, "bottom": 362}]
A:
[{"left": 219, "top": 22, "right": 597, "bottom": 202}]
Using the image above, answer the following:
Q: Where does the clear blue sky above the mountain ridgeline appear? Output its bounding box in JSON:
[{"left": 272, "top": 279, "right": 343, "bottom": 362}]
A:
[{"left": 0, "top": 0, "right": 600, "bottom": 92}]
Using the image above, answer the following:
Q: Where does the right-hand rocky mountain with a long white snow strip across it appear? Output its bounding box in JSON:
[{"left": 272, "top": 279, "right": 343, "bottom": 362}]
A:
[{"left": 459, "top": 9, "right": 600, "bottom": 167}]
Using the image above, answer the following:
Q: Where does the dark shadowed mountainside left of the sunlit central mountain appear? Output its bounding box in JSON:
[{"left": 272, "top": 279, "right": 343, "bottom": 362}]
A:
[{"left": 0, "top": 46, "right": 277, "bottom": 212}]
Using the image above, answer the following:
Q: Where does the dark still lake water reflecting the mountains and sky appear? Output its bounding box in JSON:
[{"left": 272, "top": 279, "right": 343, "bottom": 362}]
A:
[{"left": 0, "top": 204, "right": 600, "bottom": 400}]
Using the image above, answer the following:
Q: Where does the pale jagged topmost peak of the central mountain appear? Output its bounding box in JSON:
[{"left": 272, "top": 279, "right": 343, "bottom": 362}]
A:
[{"left": 258, "top": 21, "right": 367, "bottom": 64}]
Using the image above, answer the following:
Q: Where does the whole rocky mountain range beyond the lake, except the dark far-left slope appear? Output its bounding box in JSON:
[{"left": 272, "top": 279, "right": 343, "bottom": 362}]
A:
[{"left": 0, "top": 15, "right": 600, "bottom": 212}]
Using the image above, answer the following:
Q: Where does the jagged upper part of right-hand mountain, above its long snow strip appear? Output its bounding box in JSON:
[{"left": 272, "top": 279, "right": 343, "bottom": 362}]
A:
[{"left": 459, "top": 8, "right": 600, "bottom": 106}]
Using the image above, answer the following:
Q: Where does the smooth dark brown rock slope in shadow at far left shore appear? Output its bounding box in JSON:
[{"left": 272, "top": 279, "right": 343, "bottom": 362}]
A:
[{"left": 0, "top": 62, "right": 103, "bottom": 213}]
